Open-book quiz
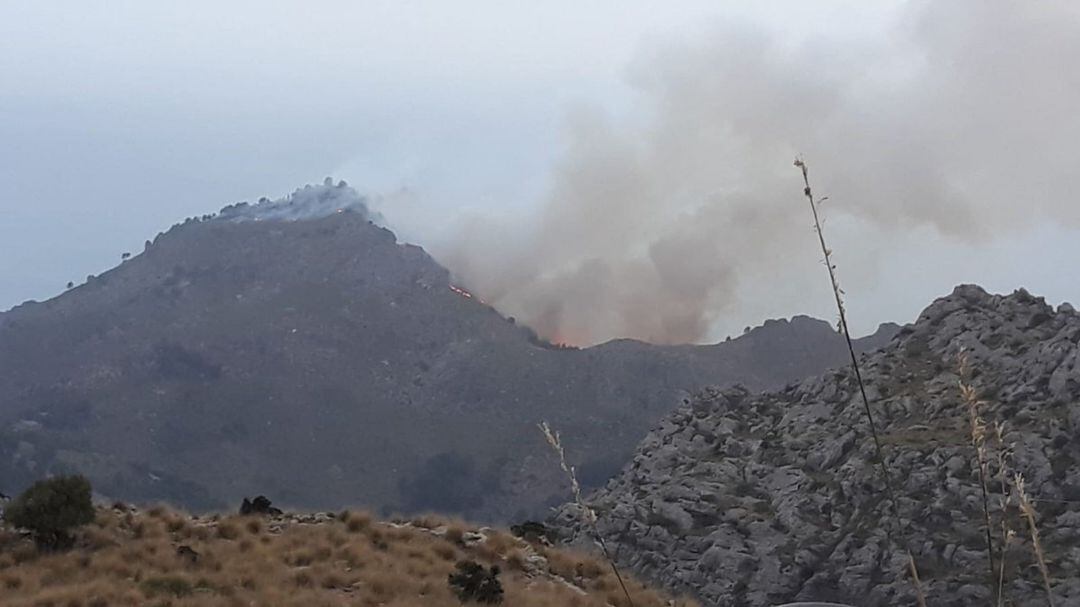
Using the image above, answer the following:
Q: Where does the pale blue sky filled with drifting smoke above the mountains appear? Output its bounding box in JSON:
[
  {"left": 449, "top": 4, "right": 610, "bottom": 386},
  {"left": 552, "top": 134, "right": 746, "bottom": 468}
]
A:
[{"left": 0, "top": 0, "right": 1080, "bottom": 343}]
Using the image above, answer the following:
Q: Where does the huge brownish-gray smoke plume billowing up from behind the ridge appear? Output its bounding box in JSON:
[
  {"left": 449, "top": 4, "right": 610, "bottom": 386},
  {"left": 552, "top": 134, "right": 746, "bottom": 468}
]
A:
[{"left": 436, "top": 0, "right": 1080, "bottom": 343}]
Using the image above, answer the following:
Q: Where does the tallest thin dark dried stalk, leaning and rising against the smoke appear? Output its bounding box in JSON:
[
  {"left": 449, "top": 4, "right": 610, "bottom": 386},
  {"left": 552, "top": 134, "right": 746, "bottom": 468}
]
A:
[{"left": 795, "top": 158, "right": 927, "bottom": 607}]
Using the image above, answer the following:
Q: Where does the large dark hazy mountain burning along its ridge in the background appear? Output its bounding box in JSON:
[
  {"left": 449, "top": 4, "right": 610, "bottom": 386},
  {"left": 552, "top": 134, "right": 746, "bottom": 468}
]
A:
[{"left": 0, "top": 184, "right": 897, "bottom": 521}]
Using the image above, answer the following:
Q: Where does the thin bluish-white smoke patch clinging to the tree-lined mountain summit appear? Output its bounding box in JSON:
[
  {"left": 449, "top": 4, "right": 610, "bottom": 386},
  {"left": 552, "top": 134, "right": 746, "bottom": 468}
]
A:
[{"left": 217, "top": 177, "right": 377, "bottom": 221}]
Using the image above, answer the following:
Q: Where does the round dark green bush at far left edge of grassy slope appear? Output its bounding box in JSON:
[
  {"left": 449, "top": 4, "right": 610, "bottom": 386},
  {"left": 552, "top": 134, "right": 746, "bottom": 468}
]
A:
[{"left": 3, "top": 475, "right": 94, "bottom": 550}]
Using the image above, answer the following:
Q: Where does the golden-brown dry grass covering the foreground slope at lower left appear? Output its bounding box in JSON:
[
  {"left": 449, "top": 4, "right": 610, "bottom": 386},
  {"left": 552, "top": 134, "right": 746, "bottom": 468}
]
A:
[{"left": 0, "top": 507, "right": 697, "bottom": 607}]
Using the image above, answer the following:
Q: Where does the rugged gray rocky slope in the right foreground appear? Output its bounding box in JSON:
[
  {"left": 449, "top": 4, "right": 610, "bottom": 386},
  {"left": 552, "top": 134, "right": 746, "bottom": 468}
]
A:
[{"left": 551, "top": 286, "right": 1080, "bottom": 607}]
